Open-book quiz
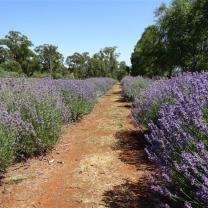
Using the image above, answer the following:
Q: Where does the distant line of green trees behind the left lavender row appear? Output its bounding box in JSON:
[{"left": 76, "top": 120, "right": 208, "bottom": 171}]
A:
[{"left": 0, "top": 31, "right": 128, "bottom": 79}]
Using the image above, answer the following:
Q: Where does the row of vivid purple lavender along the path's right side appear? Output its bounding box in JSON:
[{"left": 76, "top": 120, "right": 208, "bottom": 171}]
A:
[{"left": 121, "top": 72, "right": 208, "bottom": 208}]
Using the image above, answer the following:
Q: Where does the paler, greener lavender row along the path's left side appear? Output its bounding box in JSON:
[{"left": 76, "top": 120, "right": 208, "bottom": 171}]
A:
[{"left": 0, "top": 78, "right": 114, "bottom": 174}]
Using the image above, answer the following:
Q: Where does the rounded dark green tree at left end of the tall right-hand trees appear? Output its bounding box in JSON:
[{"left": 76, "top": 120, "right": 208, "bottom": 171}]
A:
[{"left": 131, "top": 25, "right": 168, "bottom": 76}]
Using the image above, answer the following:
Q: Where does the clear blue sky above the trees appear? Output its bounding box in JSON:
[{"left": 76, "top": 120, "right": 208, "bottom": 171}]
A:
[{"left": 0, "top": 0, "right": 170, "bottom": 64}]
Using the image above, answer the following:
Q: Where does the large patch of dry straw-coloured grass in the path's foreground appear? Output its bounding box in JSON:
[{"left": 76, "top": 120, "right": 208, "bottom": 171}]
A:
[{"left": 72, "top": 152, "right": 124, "bottom": 208}]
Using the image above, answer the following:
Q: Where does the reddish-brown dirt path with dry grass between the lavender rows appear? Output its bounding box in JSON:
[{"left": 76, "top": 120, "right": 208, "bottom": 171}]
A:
[{"left": 0, "top": 85, "right": 151, "bottom": 208}]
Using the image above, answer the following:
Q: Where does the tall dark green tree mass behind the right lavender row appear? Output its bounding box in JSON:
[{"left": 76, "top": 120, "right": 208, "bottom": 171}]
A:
[{"left": 131, "top": 0, "right": 208, "bottom": 77}]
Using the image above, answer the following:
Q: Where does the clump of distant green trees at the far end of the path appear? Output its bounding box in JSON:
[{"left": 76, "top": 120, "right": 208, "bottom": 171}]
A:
[{"left": 66, "top": 47, "right": 127, "bottom": 80}]
